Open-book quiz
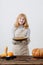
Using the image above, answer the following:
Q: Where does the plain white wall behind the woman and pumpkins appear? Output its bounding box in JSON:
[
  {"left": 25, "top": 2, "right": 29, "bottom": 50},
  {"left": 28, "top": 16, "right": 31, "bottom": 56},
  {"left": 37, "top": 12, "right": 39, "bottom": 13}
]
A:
[{"left": 0, "top": 0, "right": 43, "bottom": 54}]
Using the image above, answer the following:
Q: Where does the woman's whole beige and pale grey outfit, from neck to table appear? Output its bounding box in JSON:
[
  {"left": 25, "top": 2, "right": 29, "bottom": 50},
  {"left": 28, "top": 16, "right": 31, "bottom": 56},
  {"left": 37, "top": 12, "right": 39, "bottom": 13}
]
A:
[{"left": 13, "top": 26, "right": 30, "bottom": 55}]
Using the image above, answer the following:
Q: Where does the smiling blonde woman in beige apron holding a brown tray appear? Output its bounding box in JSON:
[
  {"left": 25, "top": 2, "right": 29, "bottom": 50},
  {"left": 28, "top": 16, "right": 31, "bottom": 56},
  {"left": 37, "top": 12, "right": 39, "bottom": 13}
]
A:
[{"left": 13, "top": 13, "right": 30, "bottom": 55}]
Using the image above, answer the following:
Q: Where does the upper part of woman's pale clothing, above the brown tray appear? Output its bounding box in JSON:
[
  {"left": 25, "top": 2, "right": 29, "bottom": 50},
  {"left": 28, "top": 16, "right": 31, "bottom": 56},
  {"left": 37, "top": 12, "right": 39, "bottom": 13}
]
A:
[{"left": 14, "top": 26, "right": 30, "bottom": 38}]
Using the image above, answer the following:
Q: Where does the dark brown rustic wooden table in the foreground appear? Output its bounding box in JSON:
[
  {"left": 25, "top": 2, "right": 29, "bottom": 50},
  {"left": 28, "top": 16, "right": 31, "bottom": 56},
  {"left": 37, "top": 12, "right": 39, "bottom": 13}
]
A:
[{"left": 0, "top": 56, "right": 43, "bottom": 65}]
